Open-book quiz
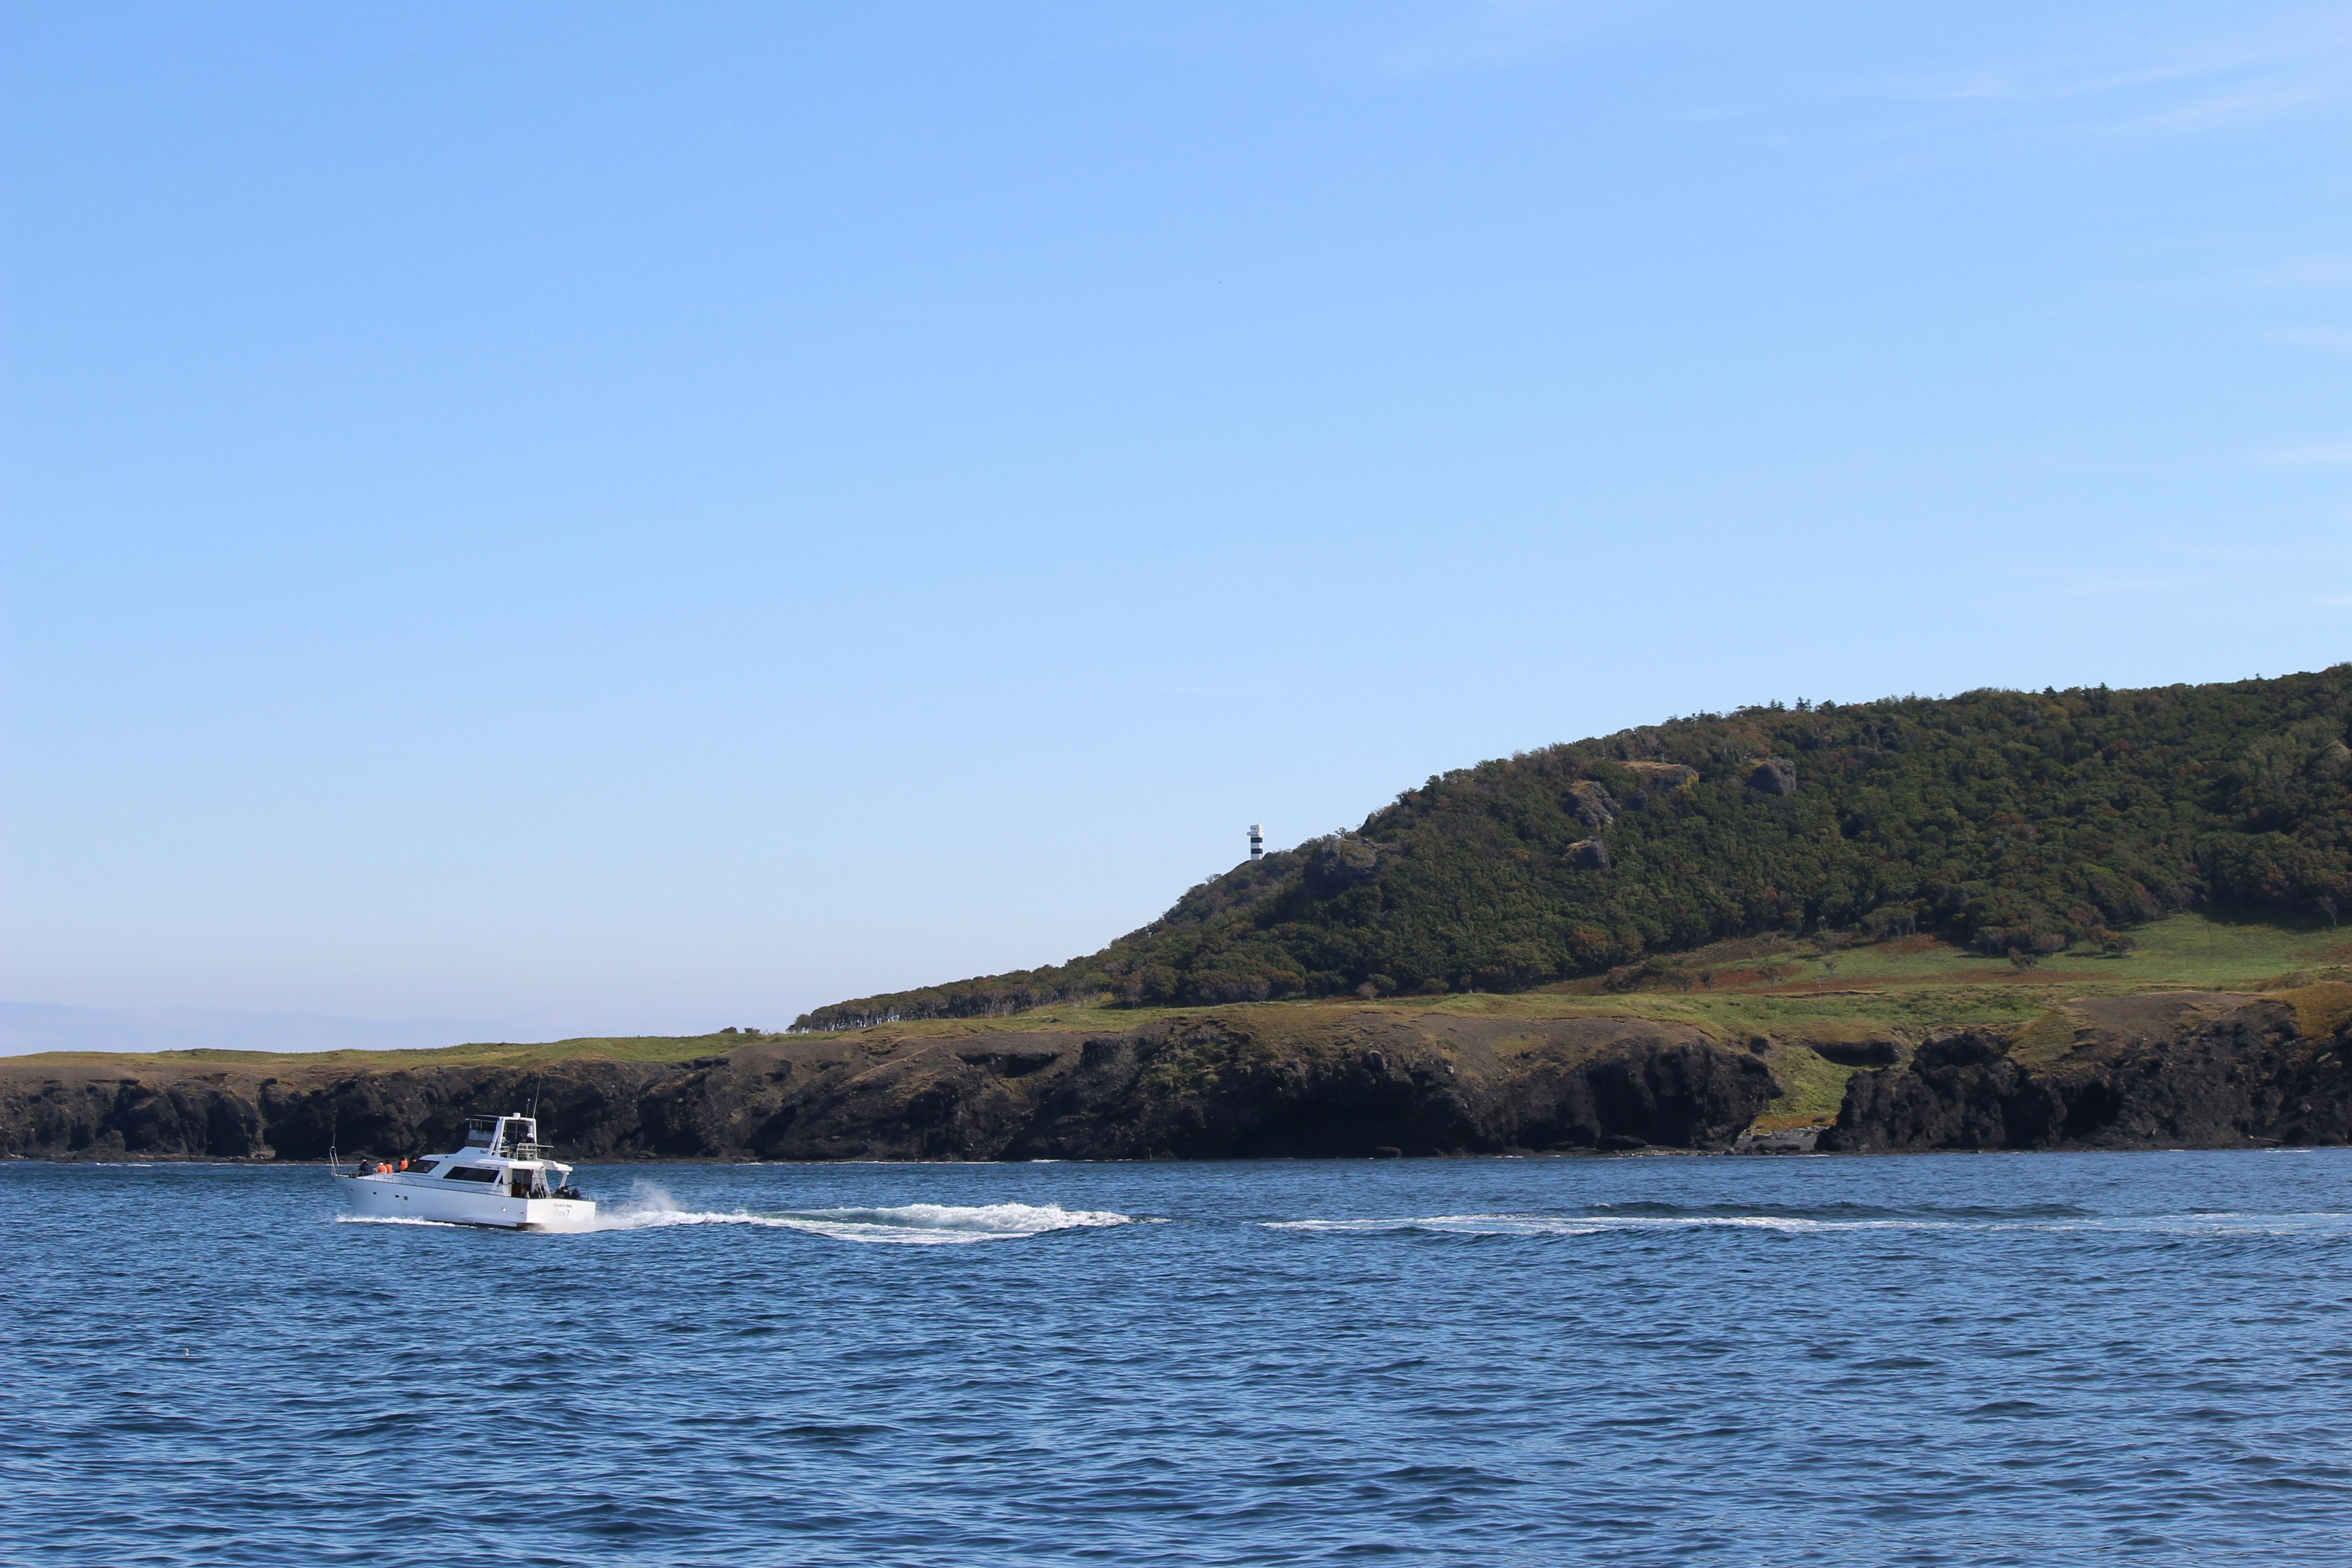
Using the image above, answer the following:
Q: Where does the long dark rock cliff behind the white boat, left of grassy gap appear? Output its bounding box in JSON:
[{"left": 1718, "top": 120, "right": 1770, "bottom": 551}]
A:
[{"left": 0, "top": 1009, "right": 1776, "bottom": 1159}]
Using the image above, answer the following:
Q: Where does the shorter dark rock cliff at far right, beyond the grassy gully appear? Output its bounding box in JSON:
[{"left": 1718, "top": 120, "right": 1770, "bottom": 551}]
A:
[{"left": 1820, "top": 995, "right": 2352, "bottom": 1152}]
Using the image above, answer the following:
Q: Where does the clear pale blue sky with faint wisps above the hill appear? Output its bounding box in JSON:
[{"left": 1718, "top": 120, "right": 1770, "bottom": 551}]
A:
[{"left": 0, "top": 0, "right": 2352, "bottom": 1048}]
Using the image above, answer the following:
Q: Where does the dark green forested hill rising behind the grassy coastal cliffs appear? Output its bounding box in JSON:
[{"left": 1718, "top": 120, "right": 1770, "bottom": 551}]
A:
[{"left": 795, "top": 665, "right": 2352, "bottom": 1030}]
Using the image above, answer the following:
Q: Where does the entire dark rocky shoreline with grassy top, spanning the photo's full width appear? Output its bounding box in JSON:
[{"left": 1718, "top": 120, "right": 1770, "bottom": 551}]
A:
[{"left": 0, "top": 985, "right": 2352, "bottom": 1161}]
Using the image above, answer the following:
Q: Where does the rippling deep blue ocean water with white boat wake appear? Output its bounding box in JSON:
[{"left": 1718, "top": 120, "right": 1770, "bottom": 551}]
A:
[{"left": 0, "top": 1152, "right": 2352, "bottom": 1568}]
